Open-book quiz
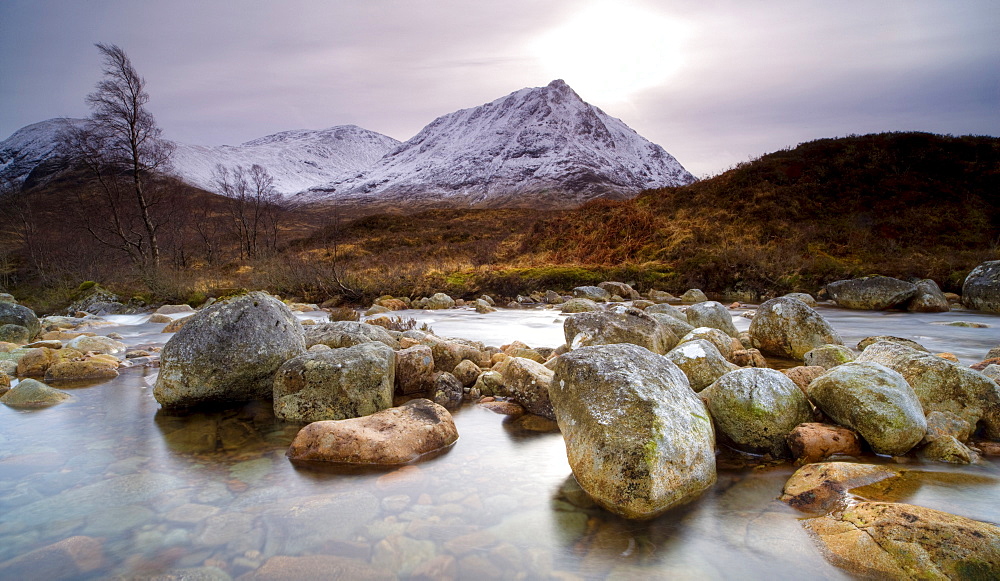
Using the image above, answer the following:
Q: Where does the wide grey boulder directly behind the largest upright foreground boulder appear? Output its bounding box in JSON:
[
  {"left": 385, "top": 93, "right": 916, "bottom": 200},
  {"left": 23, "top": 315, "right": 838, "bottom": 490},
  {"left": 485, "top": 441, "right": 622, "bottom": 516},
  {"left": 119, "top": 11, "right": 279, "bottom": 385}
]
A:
[{"left": 563, "top": 306, "right": 677, "bottom": 355}]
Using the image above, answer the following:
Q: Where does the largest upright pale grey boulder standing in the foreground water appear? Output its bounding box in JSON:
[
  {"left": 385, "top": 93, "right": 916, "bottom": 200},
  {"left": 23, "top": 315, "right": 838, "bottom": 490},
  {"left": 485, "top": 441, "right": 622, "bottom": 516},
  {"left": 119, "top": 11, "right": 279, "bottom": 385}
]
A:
[{"left": 550, "top": 344, "right": 716, "bottom": 519}]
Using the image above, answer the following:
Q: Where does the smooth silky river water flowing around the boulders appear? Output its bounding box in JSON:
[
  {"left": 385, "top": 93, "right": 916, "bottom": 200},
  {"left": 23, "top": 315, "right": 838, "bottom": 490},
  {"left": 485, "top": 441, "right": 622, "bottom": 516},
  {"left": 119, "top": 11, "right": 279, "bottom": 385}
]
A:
[{"left": 0, "top": 307, "right": 1000, "bottom": 579}]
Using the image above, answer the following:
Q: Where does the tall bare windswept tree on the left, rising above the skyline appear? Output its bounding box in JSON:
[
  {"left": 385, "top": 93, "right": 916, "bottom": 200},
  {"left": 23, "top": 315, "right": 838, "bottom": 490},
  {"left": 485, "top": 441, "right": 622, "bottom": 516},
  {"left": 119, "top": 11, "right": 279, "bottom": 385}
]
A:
[{"left": 63, "top": 43, "right": 173, "bottom": 272}]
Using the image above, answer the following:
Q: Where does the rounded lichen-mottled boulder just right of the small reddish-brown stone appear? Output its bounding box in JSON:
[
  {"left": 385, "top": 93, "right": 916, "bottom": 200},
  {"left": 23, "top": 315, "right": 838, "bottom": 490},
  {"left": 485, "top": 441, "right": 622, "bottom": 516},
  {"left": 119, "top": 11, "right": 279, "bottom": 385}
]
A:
[{"left": 807, "top": 362, "right": 927, "bottom": 456}]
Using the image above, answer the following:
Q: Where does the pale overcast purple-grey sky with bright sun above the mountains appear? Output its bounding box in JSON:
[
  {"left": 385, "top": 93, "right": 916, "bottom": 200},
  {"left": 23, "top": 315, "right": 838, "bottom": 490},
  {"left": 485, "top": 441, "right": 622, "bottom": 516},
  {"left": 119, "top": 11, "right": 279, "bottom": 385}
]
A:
[{"left": 0, "top": 0, "right": 1000, "bottom": 177}]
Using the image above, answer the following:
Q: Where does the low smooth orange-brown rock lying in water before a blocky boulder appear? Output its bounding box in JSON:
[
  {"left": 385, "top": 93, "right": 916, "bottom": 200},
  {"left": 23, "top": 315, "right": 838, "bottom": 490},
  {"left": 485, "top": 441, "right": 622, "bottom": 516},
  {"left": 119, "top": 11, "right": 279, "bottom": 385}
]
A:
[{"left": 287, "top": 399, "right": 458, "bottom": 465}]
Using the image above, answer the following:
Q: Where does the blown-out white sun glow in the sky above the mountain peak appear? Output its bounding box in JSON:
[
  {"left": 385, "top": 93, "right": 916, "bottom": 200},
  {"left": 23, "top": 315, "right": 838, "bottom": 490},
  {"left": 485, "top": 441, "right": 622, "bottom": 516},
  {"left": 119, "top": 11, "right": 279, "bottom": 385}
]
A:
[{"left": 532, "top": 2, "right": 690, "bottom": 102}]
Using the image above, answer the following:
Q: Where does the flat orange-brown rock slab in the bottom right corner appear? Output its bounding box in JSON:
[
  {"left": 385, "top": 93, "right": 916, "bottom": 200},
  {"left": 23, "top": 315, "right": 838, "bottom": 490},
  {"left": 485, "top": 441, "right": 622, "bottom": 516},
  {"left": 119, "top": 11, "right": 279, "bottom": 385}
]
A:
[{"left": 803, "top": 502, "right": 1000, "bottom": 579}]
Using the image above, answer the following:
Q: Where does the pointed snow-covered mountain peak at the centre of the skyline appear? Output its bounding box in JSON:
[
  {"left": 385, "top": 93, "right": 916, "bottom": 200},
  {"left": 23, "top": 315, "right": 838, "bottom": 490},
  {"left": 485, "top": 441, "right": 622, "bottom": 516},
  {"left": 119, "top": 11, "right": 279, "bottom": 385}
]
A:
[{"left": 301, "top": 80, "right": 695, "bottom": 207}]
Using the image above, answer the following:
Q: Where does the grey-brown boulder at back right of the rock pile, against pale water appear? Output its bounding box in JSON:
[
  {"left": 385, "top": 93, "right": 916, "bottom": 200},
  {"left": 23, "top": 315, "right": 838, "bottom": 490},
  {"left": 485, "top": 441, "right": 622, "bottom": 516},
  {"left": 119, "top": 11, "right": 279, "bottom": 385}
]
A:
[{"left": 750, "top": 297, "right": 844, "bottom": 361}]
